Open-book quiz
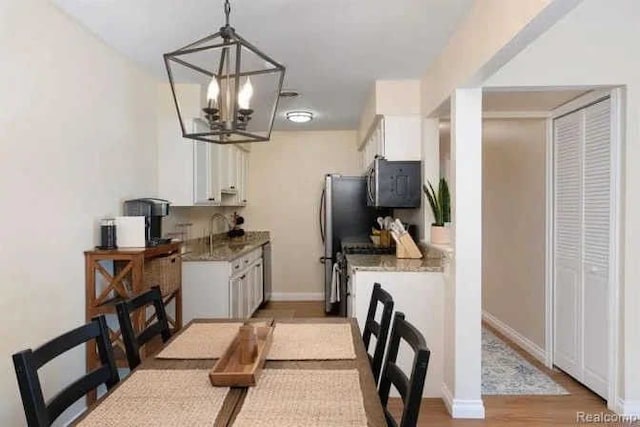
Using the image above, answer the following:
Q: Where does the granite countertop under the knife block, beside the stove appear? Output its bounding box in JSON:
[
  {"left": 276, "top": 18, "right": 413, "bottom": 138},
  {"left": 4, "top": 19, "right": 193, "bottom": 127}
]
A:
[{"left": 346, "top": 248, "right": 444, "bottom": 273}]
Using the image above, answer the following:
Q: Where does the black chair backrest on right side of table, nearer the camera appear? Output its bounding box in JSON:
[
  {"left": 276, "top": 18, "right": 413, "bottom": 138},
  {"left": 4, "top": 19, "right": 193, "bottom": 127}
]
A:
[{"left": 378, "top": 312, "right": 431, "bottom": 427}]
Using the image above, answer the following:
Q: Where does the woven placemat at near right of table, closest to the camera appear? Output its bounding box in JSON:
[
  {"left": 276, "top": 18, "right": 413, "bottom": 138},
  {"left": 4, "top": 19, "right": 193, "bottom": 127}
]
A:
[{"left": 233, "top": 369, "right": 367, "bottom": 427}]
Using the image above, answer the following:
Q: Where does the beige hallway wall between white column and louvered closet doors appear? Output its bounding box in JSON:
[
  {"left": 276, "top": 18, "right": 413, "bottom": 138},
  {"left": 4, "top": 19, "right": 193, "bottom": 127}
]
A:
[{"left": 482, "top": 119, "right": 546, "bottom": 348}]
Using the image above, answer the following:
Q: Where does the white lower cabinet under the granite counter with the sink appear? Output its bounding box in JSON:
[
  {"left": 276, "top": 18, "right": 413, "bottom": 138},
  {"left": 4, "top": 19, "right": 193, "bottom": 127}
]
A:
[{"left": 182, "top": 247, "right": 264, "bottom": 323}]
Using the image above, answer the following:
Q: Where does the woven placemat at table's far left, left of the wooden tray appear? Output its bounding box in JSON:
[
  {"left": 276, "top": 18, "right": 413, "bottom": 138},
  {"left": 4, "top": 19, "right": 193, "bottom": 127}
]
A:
[{"left": 156, "top": 323, "right": 242, "bottom": 359}]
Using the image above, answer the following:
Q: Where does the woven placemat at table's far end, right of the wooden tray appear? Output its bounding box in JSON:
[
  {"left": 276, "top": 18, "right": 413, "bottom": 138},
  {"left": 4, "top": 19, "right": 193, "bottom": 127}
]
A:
[{"left": 267, "top": 323, "right": 356, "bottom": 360}]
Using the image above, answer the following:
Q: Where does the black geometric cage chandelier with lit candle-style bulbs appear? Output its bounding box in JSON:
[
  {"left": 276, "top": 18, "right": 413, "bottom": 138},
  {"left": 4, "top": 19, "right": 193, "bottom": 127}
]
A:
[{"left": 164, "top": 0, "right": 285, "bottom": 144}]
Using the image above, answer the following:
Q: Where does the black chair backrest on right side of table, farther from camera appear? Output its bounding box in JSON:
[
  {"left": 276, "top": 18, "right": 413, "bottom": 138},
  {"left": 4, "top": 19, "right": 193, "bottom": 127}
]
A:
[{"left": 362, "top": 283, "right": 393, "bottom": 384}]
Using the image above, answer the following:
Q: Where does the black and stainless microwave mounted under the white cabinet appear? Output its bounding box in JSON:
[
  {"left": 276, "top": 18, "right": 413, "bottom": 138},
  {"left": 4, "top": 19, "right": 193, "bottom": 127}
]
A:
[{"left": 367, "top": 157, "right": 422, "bottom": 208}]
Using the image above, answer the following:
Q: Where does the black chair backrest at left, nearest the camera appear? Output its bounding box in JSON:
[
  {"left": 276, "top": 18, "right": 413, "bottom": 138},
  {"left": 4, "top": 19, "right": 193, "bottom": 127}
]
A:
[{"left": 13, "top": 316, "right": 120, "bottom": 427}]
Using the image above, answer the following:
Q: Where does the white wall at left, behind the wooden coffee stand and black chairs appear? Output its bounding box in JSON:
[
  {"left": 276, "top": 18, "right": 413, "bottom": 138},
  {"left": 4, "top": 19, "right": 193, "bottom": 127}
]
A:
[{"left": 0, "top": 0, "right": 156, "bottom": 426}]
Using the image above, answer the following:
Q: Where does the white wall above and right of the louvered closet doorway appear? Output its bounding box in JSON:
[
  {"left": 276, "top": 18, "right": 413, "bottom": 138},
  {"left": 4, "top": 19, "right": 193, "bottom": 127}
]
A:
[{"left": 485, "top": 0, "right": 640, "bottom": 413}]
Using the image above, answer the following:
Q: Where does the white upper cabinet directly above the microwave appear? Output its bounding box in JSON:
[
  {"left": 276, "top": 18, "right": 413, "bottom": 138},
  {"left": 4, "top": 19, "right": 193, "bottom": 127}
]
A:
[{"left": 359, "top": 115, "right": 422, "bottom": 172}]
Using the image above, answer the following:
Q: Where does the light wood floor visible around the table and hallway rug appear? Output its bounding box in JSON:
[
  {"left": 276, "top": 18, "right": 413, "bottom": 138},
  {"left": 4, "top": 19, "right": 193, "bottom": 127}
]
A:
[{"left": 256, "top": 302, "right": 622, "bottom": 427}]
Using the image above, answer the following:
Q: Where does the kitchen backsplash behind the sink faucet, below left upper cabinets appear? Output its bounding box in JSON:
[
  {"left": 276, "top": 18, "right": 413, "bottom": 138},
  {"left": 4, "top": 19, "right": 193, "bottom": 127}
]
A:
[{"left": 162, "top": 206, "right": 251, "bottom": 239}]
